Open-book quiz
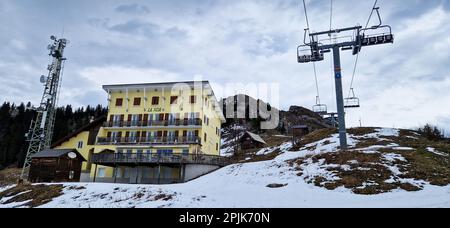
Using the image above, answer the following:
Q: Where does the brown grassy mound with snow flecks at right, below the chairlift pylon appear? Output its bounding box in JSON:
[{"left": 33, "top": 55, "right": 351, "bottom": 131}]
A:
[{"left": 290, "top": 128, "right": 450, "bottom": 194}]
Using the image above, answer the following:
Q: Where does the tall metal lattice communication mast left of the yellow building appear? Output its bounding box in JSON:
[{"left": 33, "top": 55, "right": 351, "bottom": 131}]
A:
[{"left": 20, "top": 36, "right": 68, "bottom": 181}]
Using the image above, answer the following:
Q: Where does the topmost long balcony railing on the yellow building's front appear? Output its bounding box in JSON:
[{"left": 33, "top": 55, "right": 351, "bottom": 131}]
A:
[{"left": 103, "top": 119, "right": 202, "bottom": 128}]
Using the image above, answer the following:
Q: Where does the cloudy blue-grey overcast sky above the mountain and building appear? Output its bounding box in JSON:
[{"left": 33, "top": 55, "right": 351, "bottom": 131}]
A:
[{"left": 0, "top": 0, "right": 450, "bottom": 132}]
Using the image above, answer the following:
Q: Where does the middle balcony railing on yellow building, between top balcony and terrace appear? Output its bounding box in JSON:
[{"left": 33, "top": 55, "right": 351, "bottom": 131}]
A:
[{"left": 97, "top": 137, "right": 202, "bottom": 145}]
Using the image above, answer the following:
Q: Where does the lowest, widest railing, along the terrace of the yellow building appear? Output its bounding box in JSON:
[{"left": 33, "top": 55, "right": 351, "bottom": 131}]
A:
[{"left": 91, "top": 153, "right": 231, "bottom": 167}]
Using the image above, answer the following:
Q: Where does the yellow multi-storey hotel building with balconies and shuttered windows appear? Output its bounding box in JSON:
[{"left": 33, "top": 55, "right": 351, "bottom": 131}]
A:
[{"left": 55, "top": 81, "right": 225, "bottom": 183}]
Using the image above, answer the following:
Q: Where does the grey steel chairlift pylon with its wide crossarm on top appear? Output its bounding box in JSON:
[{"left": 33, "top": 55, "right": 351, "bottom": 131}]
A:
[{"left": 297, "top": 8, "right": 394, "bottom": 150}]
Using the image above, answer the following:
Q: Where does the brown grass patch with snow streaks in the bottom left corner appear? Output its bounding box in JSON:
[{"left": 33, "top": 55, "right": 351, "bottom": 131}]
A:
[{"left": 0, "top": 184, "right": 64, "bottom": 207}]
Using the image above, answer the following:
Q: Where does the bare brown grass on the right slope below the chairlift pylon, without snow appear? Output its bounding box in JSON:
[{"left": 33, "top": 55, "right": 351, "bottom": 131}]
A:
[{"left": 289, "top": 128, "right": 450, "bottom": 194}]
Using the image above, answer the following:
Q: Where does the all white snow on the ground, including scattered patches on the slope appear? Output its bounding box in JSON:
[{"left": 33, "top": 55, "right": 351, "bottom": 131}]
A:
[{"left": 0, "top": 129, "right": 450, "bottom": 208}]
